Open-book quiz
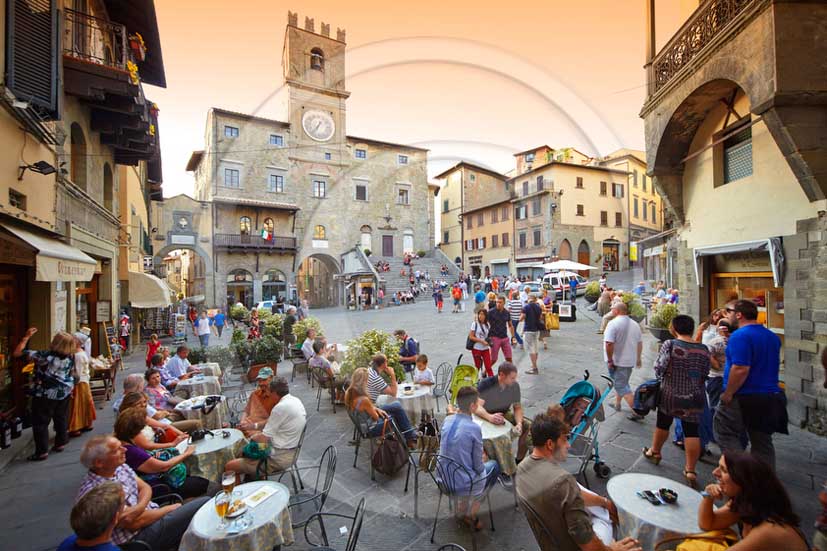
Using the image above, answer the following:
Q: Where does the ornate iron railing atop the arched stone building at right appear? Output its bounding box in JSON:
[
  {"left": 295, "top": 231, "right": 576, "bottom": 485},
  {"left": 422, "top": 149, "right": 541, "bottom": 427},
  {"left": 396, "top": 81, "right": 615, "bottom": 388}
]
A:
[{"left": 649, "top": 0, "right": 758, "bottom": 94}]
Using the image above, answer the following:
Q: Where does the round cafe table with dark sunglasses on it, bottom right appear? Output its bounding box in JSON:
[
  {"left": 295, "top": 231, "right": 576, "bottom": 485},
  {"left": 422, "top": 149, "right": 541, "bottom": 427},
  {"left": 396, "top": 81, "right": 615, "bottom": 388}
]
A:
[{"left": 606, "top": 473, "right": 701, "bottom": 549}]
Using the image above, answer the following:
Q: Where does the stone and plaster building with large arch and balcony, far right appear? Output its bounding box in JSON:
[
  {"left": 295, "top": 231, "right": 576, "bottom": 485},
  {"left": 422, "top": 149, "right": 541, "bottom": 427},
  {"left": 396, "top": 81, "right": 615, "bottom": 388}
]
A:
[{"left": 641, "top": 0, "right": 827, "bottom": 433}]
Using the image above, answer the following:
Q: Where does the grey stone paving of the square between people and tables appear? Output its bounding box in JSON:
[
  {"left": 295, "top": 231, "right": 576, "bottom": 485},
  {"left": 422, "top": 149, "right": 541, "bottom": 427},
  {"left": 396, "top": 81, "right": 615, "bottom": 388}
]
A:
[{"left": 0, "top": 278, "right": 827, "bottom": 550}]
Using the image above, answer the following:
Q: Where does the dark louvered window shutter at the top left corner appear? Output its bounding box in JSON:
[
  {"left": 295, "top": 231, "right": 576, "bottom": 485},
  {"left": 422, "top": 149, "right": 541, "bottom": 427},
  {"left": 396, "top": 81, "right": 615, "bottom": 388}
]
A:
[{"left": 6, "top": 0, "right": 61, "bottom": 120}]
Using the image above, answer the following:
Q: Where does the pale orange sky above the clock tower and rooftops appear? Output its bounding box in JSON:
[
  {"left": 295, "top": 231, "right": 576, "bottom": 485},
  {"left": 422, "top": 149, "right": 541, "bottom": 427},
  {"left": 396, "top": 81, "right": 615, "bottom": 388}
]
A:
[{"left": 147, "top": 0, "right": 697, "bottom": 196}]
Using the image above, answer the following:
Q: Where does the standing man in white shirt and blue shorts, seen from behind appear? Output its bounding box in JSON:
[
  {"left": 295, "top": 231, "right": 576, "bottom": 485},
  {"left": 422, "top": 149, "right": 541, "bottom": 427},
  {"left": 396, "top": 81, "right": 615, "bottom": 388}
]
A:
[{"left": 603, "top": 302, "right": 643, "bottom": 421}]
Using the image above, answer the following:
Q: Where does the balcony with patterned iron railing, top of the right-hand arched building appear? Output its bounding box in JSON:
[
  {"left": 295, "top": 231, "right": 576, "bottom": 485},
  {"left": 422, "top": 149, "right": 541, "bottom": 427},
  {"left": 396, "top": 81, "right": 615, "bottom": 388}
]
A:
[{"left": 647, "top": 0, "right": 766, "bottom": 99}]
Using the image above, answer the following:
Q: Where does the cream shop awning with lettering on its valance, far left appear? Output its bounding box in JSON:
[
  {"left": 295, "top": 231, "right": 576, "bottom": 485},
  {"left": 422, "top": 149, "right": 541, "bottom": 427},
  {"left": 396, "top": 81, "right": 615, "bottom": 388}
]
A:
[{"left": 2, "top": 224, "right": 97, "bottom": 281}]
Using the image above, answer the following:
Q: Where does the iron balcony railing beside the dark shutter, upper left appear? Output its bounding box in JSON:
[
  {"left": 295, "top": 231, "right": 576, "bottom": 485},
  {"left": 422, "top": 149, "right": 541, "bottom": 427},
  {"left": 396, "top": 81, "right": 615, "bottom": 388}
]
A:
[{"left": 63, "top": 9, "right": 129, "bottom": 71}]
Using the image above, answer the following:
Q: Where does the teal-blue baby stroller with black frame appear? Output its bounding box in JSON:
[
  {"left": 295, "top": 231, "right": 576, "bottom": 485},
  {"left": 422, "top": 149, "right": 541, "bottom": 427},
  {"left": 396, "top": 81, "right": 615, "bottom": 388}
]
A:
[{"left": 560, "top": 370, "right": 614, "bottom": 487}]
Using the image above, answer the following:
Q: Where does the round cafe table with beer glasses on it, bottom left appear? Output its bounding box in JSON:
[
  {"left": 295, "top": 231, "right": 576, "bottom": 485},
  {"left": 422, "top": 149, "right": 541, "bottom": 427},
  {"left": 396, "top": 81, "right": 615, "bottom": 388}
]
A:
[{"left": 178, "top": 480, "right": 293, "bottom": 551}]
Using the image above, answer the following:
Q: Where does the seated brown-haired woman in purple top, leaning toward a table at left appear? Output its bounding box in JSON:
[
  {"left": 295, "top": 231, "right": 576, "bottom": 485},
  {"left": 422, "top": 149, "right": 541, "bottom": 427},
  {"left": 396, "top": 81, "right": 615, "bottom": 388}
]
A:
[{"left": 115, "top": 408, "right": 210, "bottom": 499}]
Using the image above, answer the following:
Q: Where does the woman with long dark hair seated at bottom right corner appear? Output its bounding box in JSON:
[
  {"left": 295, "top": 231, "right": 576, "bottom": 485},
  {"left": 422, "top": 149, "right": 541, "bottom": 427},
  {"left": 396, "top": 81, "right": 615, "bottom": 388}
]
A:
[{"left": 698, "top": 452, "right": 809, "bottom": 551}]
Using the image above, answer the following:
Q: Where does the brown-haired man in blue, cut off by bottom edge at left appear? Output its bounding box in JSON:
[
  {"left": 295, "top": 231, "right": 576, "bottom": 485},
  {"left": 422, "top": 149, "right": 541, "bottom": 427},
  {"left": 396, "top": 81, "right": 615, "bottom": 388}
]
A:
[{"left": 57, "top": 482, "right": 124, "bottom": 551}]
